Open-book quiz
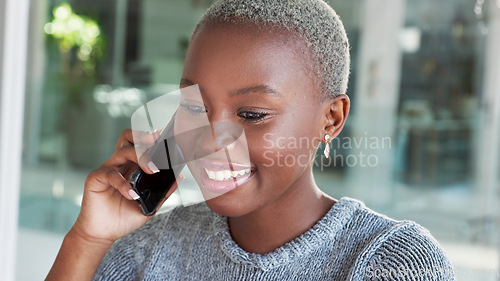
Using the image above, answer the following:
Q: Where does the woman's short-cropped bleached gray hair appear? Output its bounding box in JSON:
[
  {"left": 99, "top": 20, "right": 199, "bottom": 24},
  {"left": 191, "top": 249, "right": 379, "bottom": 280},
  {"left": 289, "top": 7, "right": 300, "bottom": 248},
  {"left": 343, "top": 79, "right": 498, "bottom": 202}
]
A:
[{"left": 193, "top": 0, "right": 350, "bottom": 98}]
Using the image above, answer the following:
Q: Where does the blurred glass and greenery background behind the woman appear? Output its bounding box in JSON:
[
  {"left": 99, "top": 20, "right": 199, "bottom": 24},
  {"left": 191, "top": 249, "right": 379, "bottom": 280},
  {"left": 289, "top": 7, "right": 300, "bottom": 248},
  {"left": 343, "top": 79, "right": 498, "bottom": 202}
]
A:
[{"left": 0, "top": 0, "right": 500, "bottom": 280}]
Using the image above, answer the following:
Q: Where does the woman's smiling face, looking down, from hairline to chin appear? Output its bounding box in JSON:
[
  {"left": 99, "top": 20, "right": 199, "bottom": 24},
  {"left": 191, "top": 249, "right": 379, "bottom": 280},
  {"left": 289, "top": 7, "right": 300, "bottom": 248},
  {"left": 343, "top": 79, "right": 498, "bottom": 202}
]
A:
[{"left": 176, "top": 26, "right": 324, "bottom": 216}]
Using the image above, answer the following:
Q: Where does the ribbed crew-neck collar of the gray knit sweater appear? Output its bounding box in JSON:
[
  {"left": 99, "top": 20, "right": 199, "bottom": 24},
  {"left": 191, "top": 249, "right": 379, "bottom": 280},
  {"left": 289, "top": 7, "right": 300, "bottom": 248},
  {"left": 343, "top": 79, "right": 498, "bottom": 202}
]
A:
[{"left": 213, "top": 197, "right": 363, "bottom": 271}]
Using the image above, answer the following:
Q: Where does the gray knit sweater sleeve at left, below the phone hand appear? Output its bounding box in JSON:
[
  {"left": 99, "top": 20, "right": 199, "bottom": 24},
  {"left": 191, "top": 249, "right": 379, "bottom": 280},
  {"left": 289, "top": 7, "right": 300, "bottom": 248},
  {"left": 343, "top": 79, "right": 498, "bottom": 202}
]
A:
[{"left": 93, "top": 209, "right": 175, "bottom": 281}]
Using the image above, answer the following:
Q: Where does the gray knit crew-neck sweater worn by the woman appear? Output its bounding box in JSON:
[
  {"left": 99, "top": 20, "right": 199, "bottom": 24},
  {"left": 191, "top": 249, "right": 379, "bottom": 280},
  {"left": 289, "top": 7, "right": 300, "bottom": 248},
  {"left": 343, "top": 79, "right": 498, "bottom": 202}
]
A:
[{"left": 94, "top": 198, "right": 455, "bottom": 281}]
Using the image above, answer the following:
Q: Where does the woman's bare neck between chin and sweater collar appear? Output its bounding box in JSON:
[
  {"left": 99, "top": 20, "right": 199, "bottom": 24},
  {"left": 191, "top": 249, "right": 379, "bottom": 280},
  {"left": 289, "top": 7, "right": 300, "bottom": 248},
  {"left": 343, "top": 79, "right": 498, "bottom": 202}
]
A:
[{"left": 229, "top": 172, "right": 335, "bottom": 254}]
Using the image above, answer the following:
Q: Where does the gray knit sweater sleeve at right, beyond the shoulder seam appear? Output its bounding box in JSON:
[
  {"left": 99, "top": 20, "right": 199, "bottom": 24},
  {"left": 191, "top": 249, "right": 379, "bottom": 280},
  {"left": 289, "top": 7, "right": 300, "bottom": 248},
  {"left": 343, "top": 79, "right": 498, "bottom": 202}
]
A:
[{"left": 352, "top": 222, "right": 455, "bottom": 281}]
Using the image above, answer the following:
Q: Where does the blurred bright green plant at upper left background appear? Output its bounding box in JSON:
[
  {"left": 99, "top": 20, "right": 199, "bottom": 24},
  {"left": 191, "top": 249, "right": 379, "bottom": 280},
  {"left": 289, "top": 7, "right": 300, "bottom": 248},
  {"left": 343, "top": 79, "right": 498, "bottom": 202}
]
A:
[{"left": 43, "top": 3, "right": 106, "bottom": 103}]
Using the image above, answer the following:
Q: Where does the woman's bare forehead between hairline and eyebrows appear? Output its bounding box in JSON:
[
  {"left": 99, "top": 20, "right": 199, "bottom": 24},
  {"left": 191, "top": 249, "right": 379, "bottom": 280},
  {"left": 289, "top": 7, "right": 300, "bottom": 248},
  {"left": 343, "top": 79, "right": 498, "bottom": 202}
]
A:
[{"left": 183, "top": 24, "right": 313, "bottom": 95}]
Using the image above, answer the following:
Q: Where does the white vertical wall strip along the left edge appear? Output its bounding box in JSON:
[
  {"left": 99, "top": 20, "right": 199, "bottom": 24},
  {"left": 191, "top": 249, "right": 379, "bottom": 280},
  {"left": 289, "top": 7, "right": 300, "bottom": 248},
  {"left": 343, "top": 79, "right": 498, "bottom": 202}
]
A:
[{"left": 0, "top": 0, "right": 29, "bottom": 281}]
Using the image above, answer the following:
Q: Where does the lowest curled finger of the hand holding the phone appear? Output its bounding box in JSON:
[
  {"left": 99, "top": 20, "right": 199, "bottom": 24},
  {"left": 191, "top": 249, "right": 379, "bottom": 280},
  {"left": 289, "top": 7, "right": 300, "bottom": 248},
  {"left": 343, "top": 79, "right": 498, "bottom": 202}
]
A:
[{"left": 85, "top": 169, "right": 134, "bottom": 200}]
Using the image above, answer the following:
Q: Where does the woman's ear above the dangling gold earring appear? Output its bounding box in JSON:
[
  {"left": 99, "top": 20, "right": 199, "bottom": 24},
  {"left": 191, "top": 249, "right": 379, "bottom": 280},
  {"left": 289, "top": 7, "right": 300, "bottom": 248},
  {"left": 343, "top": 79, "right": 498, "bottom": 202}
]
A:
[{"left": 321, "top": 95, "right": 351, "bottom": 140}]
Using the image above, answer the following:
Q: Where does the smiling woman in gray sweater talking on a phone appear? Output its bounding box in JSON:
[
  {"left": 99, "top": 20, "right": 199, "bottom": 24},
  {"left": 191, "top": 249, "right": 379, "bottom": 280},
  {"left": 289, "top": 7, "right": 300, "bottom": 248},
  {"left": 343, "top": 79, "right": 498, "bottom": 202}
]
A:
[{"left": 48, "top": 0, "right": 454, "bottom": 280}]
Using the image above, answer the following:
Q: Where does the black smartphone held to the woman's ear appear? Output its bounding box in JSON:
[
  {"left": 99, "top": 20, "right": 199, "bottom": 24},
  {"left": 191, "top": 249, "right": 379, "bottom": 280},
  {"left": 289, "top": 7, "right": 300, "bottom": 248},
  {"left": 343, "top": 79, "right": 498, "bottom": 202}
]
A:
[{"left": 129, "top": 115, "right": 185, "bottom": 216}]
